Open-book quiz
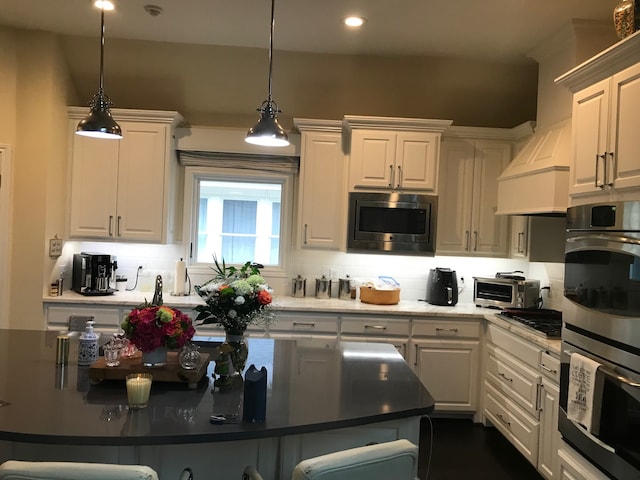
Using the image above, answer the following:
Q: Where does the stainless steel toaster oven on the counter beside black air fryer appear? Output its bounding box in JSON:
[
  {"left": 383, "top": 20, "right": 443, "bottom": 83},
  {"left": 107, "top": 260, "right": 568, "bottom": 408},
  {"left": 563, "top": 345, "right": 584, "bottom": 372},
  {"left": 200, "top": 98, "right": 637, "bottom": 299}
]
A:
[{"left": 473, "top": 273, "right": 540, "bottom": 308}]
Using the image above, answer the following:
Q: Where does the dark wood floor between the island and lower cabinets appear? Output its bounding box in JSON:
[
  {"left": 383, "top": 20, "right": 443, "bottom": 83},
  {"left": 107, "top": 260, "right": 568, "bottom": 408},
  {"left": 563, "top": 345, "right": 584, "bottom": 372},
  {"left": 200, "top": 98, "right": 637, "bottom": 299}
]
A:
[{"left": 418, "top": 418, "right": 542, "bottom": 480}]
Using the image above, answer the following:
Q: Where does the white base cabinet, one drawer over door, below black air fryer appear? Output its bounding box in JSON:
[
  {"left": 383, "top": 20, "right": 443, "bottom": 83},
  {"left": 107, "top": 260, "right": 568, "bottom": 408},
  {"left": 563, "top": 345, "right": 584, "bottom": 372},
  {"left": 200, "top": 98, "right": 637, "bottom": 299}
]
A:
[{"left": 409, "top": 319, "right": 480, "bottom": 412}]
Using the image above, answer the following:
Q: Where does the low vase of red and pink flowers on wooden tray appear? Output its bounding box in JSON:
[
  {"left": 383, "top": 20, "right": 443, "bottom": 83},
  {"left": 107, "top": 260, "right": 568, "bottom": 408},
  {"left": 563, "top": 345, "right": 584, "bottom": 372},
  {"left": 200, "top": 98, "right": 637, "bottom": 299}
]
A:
[{"left": 120, "top": 304, "right": 195, "bottom": 367}]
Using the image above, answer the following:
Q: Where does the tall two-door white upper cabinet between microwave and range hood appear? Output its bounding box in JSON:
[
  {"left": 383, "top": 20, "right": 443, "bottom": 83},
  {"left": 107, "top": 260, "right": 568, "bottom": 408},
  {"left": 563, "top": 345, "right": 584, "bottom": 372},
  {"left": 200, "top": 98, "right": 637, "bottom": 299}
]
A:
[{"left": 436, "top": 138, "right": 511, "bottom": 257}]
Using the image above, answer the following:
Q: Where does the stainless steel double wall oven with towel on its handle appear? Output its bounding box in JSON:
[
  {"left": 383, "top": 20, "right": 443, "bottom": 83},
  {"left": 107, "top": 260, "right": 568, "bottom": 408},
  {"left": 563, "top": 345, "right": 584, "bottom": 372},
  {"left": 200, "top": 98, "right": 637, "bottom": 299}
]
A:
[{"left": 558, "top": 202, "right": 640, "bottom": 480}]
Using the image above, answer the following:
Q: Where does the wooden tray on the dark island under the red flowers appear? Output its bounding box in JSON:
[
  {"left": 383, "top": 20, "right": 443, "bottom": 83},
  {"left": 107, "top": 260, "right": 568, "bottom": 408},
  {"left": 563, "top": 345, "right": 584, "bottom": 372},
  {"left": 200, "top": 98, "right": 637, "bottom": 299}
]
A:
[{"left": 89, "top": 352, "right": 209, "bottom": 388}]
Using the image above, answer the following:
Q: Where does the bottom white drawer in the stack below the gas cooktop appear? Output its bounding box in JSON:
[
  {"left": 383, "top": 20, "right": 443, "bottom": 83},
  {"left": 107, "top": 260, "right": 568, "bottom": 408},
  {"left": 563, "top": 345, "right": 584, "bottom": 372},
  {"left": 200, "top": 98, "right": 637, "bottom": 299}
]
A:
[{"left": 484, "top": 382, "right": 540, "bottom": 466}]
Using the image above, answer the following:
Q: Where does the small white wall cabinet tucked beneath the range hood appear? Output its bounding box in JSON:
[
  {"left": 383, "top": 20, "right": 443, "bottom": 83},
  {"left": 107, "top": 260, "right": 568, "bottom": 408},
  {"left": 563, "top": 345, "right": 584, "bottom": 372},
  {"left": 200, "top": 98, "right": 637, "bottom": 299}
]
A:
[{"left": 510, "top": 215, "right": 566, "bottom": 263}]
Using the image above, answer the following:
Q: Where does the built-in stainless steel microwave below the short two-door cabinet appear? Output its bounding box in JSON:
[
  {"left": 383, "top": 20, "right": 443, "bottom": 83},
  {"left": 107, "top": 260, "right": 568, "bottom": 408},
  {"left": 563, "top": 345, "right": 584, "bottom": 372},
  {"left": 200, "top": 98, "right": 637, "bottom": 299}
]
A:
[{"left": 347, "top": 192, "right": 438, "bottom": 255}]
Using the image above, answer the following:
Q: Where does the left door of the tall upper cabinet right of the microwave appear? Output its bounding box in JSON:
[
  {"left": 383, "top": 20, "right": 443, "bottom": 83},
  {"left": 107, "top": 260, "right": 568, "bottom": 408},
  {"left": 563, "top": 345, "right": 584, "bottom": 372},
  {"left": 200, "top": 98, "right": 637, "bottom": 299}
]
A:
[{"left": 436, "top": 139, "right": 475, "bottom": 255}]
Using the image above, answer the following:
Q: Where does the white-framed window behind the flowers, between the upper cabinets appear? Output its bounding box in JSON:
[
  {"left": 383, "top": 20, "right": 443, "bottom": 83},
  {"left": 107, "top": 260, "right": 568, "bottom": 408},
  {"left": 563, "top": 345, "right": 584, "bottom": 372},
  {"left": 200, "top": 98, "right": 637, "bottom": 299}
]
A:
[{"left": 185, "top": 167, "right": 292, "bottom": 269}]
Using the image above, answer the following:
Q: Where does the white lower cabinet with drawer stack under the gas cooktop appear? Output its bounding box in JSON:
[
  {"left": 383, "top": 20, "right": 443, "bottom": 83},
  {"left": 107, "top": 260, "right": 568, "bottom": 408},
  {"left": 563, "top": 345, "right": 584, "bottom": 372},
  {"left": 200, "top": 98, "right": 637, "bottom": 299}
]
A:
[{"left": 483, "top": 323, "right": 560, "bottom": 479}]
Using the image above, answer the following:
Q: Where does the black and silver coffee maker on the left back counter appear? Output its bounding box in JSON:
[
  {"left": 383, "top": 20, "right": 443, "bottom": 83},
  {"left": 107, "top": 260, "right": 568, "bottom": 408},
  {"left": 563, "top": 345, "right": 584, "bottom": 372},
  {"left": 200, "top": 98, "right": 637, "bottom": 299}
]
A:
[{"left": 72, "top": 252, "right": 116, "bottom": 296}]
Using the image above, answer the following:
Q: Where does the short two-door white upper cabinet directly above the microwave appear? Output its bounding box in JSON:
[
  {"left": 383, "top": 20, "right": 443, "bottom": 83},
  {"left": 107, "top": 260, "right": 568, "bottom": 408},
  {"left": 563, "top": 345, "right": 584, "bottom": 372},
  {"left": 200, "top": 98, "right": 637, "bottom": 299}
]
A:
[{"left": 344, "top": 115, "right": 451, "bottom": 194}]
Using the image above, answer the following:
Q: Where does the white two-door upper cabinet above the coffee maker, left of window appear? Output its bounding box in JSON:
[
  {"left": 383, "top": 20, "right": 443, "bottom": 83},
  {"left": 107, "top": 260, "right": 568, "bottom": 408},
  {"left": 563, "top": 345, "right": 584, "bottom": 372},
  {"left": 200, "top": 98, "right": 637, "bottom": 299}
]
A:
[{"left": 69, "top": 107, "right": 182, "bottom": 242}]
